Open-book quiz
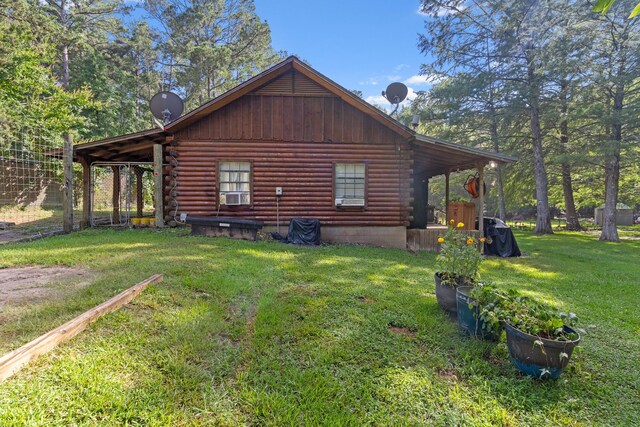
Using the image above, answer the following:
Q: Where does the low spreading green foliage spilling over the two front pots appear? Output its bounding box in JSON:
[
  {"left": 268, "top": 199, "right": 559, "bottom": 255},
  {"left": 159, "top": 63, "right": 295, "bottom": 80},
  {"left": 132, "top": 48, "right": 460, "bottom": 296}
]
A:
[{"left": 471, "top": 285, "right": 578, "bottom": 341}]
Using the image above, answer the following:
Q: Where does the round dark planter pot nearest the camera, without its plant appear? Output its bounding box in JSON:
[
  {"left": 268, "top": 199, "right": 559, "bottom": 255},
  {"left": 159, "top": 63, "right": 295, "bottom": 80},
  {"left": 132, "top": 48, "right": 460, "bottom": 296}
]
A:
[{"left": 505, "top": 323, "right": 580, "bottom": 379}]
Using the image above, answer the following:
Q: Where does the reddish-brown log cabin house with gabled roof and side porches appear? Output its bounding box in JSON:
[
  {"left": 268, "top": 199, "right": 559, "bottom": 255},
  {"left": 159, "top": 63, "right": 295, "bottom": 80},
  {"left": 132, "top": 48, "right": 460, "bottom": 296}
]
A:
[{"left": 69, "top": 57, "right": 514, "bottom": 248}]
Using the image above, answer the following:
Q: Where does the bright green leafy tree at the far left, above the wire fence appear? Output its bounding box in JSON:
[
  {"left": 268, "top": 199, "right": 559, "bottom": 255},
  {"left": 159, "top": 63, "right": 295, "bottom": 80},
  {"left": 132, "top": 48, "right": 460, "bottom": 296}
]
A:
[{"left": 0, "top": 0, "right": 92, "bottom": 148}]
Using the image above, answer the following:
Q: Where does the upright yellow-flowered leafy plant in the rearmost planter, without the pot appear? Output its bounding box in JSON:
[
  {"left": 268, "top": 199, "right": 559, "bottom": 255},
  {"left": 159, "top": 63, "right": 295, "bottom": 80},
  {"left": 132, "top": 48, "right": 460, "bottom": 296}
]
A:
[{"left": 436, "top": 220, "right": 484, "bottom": 286}]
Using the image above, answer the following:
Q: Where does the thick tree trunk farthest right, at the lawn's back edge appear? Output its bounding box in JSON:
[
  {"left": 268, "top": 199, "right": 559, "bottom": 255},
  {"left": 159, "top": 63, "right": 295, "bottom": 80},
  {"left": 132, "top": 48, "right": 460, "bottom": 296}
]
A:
[{"left": 600, "top": 81, "right": 624, "bottom": 242}]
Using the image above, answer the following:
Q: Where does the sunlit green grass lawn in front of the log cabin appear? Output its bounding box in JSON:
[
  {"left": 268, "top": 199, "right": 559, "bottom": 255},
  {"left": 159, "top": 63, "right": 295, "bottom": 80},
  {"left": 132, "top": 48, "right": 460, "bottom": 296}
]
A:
[{"left": 0, "top": 230, "right": 640, "bottom": 426}]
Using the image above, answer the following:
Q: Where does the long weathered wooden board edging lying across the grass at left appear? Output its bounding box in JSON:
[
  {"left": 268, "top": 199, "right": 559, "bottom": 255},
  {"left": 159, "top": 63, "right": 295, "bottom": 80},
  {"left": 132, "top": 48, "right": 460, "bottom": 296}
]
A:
[{"left": 0, "top": 274, "right": 163, "bottom": 382}]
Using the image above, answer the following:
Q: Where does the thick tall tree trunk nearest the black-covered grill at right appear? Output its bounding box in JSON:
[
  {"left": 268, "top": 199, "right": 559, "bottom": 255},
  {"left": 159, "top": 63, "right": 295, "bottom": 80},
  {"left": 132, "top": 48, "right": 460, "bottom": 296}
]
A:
[{"left": 527, "top": 54, "right": 553, "bottom": 234}]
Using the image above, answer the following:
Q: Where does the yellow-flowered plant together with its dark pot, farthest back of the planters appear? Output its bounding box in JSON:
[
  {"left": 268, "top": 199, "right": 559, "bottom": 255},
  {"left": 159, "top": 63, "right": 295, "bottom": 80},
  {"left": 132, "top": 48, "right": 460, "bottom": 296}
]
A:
[{"left": 435, "top": 220, "right": 484, "bottom": 317}]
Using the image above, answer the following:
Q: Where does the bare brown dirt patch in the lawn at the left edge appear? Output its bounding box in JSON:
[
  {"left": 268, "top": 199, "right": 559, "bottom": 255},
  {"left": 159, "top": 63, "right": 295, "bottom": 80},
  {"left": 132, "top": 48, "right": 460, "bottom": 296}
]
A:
[{"left": 0, "top": 267, "right": 91, "bottom": 307}]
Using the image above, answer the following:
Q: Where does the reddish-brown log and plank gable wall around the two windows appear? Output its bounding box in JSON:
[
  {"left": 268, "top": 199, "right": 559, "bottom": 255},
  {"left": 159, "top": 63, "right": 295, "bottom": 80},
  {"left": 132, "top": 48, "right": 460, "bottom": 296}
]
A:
[{"left": 165, "top": 91, "right": 412, "bottom": 226}]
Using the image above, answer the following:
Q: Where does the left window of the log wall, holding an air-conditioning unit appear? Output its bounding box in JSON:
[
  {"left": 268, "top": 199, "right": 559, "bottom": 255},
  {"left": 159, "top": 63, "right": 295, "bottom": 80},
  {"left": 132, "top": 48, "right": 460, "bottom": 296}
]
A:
[{"left": 218, "top": 162, "right": 251, "bottom": 206}]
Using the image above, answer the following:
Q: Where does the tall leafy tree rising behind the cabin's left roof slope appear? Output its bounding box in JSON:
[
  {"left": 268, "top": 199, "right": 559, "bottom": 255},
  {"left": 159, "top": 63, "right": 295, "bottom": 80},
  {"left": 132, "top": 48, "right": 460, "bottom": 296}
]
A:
[{"left": 145, "top": 0, "right": 280, "bottom": 107}]
